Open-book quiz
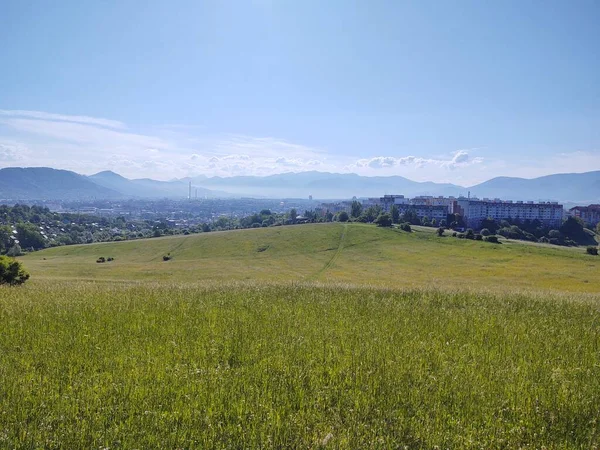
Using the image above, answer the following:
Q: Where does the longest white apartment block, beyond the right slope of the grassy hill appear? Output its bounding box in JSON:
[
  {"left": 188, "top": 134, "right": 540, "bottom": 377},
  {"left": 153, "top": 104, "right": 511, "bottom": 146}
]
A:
[{"left": 450, "top": 197, "right": 564, "bottom": 228}]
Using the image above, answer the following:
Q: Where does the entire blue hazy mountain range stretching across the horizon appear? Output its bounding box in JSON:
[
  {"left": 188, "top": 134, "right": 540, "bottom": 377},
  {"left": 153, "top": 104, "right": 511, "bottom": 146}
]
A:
[{"left": 0, "top": 167, "right": 600, "bottom": 204}]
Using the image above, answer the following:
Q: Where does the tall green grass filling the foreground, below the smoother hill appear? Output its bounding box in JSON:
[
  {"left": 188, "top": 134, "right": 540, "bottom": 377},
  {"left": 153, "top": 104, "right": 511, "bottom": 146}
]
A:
[{"left": 0, "top": 282, "right": 600, "bottom": 448}]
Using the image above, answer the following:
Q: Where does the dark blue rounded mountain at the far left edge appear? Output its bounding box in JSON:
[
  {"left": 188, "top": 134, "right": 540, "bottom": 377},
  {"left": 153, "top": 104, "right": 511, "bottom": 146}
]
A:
[{"left": 0, "top": 167, "right": 122, "bottom": 200}]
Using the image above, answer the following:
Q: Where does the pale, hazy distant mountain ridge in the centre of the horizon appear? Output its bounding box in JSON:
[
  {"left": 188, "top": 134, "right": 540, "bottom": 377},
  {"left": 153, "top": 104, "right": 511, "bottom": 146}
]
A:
[{"left": 185, "top": 172, "right": 467, "bottom": 199}]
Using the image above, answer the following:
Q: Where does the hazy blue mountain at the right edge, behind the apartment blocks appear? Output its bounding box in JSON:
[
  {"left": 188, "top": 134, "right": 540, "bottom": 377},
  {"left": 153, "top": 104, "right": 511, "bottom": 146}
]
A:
[{"left": 469, "top": 171, "right": 600, "bottom": 204}]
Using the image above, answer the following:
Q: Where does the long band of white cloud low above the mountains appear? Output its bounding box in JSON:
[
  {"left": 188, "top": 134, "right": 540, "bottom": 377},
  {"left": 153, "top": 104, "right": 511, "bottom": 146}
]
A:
[{"left": 0, "top": 110, "right": 600, "bottom": 185}]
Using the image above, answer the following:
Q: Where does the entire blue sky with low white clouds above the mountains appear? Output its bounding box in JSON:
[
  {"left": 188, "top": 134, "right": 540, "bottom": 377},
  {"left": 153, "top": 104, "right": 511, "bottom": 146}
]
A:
[{"left": 0, "top": 0, "right": 600, "bottom": 186}]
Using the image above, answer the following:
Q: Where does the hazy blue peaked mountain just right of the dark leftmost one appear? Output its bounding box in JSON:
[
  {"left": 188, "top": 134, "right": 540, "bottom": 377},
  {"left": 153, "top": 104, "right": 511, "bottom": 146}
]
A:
[{"left": 88, "top": 170, "right": 224, "bottom": 198}]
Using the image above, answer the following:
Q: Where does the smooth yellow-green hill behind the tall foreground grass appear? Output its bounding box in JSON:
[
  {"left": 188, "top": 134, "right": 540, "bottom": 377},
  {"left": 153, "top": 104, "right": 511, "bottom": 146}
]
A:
[{"left": 22, "top": 223, "right": 600, "bottom": 293}]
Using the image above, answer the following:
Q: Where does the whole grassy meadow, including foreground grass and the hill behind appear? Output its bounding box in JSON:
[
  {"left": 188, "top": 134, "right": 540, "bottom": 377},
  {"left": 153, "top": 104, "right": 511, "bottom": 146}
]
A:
[{"left": 0, "top": 224, "right": 600, "bottom": 449}]
